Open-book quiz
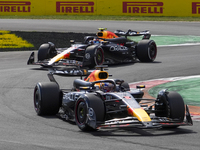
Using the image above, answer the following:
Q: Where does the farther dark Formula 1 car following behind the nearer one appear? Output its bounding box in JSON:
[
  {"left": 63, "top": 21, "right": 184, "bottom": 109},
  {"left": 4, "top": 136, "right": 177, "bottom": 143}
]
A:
[{"left": 27, "top": 28, "right": 157, "bottom": 68}]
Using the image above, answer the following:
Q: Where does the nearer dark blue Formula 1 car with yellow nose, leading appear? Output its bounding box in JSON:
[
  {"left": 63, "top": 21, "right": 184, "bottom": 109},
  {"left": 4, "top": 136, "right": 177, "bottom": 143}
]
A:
[{"left": 34, "top": 66, "right": 193, "bottom": 131}]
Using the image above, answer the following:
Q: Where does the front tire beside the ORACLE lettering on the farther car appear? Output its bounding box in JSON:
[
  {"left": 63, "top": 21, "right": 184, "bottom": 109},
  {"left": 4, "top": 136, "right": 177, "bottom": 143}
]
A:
[{"left": 84, "top": 45, "right": 104, "bottom": 68}]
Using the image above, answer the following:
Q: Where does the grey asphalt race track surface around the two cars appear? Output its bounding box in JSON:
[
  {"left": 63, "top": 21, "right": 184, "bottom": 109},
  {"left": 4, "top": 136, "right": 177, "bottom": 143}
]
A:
[{"left": 0, "top": 19, "right": 200, "bottom": 150}]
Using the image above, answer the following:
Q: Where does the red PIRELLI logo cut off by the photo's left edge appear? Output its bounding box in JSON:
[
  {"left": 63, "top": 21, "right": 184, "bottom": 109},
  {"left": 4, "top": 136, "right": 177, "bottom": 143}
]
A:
[{"left": 0, "top": 1, "right": 31, "bottom": 13}]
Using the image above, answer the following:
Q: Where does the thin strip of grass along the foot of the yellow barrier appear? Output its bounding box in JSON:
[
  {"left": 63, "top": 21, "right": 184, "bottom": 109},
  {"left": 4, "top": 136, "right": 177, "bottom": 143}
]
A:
[{"left": 0, "top": 15, "right": 200, "bottom": 21}]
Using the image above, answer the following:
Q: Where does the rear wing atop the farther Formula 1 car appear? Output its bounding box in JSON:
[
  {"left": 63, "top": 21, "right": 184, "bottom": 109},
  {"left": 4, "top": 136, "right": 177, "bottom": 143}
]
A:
[{"left": 114, "top": 29, "right": 151, "bottom": 39}]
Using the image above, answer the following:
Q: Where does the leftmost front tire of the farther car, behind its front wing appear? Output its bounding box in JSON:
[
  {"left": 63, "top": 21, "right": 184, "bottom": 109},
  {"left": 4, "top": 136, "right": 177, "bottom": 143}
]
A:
[{"left": 38, "top": 43, "right": 57, "bottom": 61}]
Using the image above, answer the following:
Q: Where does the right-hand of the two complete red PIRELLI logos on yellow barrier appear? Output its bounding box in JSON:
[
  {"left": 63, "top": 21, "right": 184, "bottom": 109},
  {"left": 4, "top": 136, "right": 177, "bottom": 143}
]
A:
[{"left": 123, "top": 2, "right": 163, "bottom": 14}]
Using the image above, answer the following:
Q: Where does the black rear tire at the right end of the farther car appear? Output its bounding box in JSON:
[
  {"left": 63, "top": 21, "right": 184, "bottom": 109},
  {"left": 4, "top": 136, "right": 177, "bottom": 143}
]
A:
[{"left": 136, "top": 40, "right": 157, "bottom": 62}]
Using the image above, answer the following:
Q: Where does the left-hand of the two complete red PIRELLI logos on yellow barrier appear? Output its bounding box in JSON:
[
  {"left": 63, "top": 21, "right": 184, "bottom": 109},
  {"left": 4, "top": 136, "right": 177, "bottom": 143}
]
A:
[{"left": 56, "top": 1, "right": 94, "bottom": 14}]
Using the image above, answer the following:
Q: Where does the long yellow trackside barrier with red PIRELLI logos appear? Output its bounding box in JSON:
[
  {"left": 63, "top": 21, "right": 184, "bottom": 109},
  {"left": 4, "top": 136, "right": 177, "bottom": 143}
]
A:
[{"left": 0, "top": 0, "right": 200, "bottom": 17}]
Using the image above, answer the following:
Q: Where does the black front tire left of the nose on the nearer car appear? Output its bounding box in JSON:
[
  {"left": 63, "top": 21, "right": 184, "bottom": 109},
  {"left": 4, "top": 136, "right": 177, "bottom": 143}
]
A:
[{"left": 74, "top": 94, "right": 105, "bottom": 131}]
